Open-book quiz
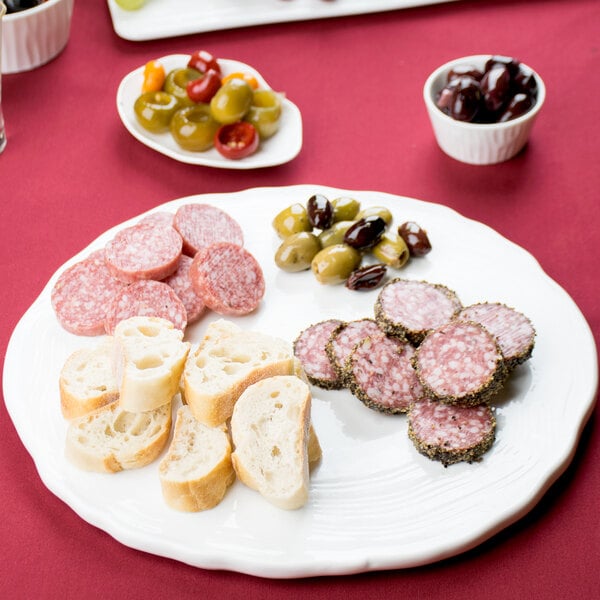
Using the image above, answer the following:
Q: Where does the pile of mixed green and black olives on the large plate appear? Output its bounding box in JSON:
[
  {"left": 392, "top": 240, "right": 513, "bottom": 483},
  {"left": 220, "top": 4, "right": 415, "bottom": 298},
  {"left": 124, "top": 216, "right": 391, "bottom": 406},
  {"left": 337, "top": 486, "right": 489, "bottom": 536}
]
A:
[{"left": 273, "top": 194, "right": 431, "bottom": 290}]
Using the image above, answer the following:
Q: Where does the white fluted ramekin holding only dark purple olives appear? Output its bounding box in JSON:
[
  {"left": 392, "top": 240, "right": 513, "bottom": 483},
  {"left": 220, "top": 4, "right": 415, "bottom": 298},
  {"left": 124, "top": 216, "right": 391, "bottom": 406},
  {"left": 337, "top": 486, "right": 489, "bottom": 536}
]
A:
[{"left": 423, "top": 54, "right": 546, "bottom": 165}]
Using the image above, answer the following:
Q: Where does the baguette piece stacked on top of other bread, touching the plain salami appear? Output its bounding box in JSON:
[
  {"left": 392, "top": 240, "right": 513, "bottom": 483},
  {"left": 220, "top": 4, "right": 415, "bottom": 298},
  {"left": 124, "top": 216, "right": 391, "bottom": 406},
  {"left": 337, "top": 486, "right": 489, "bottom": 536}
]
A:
[{"left": 114, "top": 317, "right": 190, "bottom": 412}]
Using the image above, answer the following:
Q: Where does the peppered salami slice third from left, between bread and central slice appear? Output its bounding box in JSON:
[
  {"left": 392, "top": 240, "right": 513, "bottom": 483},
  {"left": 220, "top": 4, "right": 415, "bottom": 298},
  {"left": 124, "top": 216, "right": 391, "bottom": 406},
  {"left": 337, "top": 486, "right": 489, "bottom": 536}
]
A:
[{"left": 348, "top": 332, "right": 424, "bottom": 414}]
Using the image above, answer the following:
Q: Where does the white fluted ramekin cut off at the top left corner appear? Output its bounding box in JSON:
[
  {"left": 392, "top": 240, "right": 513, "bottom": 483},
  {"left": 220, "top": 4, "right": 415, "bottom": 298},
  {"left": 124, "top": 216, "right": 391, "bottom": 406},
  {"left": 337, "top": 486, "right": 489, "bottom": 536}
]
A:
[{"left": 2, "top": 0, "right": 74, "bottom": 73}]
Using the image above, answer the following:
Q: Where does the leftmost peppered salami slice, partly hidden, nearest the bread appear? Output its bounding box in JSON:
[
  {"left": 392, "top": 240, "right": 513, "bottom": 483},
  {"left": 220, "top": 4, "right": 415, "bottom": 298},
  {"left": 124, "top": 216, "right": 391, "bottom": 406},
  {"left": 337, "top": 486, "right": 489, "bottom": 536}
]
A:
[{"left": 294, "top": 319, "right": 343, "bottom": 390}]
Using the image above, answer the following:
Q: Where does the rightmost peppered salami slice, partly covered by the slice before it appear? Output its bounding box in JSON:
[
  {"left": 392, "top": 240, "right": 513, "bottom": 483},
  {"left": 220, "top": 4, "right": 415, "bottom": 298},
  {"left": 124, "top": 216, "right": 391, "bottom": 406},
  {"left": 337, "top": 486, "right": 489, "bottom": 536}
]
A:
[{"left": 458, "top": 302, "right": 535, "bottom": 369}]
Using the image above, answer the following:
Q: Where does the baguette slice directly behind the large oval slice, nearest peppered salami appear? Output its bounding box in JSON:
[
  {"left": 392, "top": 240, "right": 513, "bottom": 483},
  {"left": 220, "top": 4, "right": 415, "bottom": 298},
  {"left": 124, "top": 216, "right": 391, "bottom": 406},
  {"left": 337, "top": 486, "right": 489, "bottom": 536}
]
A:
[{"left": 183, "top": 319, "right": 298, "bottom": 427}]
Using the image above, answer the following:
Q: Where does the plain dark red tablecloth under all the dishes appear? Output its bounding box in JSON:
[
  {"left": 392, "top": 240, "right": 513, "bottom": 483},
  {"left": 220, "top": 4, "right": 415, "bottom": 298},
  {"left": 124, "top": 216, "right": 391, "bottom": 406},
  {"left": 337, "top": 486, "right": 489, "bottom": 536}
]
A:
[{"left": 0, "top": 0, "right": 600, "bottom": 599}]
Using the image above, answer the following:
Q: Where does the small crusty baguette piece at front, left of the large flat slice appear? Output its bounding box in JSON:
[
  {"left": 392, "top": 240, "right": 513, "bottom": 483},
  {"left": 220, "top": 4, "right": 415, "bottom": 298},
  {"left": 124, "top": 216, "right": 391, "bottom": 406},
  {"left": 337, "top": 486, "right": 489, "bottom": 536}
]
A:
[{"left": 158, "top": 406, "right": 235, "bottom": 512}]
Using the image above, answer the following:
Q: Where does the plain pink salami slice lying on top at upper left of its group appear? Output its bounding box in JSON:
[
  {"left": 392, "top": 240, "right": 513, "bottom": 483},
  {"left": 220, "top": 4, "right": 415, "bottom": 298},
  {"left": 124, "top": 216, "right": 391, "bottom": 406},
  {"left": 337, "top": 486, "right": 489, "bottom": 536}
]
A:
[{"left": 105, "top": 223, "right": 182, "bottom": 283}]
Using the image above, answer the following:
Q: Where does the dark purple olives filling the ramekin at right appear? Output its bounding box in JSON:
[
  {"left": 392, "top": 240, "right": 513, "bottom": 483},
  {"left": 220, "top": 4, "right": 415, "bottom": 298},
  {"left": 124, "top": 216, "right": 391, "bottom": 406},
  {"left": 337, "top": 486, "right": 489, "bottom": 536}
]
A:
[{"left": 436, "top": 56, "right": 537, "bottom": 123}]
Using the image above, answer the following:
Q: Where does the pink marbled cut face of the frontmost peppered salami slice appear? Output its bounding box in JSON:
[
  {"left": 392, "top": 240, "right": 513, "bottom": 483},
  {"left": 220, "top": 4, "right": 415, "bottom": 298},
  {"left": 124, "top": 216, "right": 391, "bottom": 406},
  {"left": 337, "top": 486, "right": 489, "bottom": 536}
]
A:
[{"left": 408, "top": 399, "right": 495, "bottom": 452}]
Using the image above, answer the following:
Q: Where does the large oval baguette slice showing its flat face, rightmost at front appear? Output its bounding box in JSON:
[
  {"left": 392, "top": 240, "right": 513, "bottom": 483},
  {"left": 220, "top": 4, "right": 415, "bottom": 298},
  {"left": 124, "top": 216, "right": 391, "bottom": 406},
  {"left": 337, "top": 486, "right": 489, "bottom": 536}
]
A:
[{"left": 231, "top": 375, "right": 311, "bottom": 510}]
